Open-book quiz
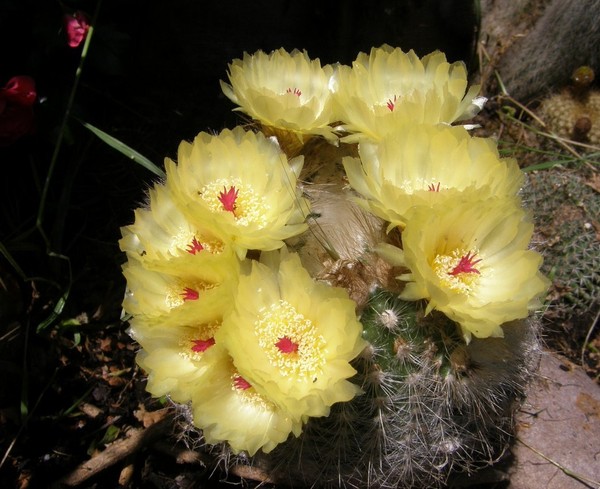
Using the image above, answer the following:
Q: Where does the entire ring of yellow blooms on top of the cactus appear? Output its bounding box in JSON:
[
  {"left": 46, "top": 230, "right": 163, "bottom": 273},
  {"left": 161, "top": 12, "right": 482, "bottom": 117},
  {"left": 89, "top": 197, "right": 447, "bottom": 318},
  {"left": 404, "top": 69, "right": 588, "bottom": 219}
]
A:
[{"left": 120, "top": 46, "right": 548, "bottom": 455}]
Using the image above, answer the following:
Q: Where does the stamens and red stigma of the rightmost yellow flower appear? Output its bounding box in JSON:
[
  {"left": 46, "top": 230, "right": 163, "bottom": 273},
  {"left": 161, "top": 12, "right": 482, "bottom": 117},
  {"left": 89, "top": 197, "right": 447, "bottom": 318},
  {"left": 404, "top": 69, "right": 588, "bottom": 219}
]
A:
[{"left": 433, "top": 248, "right": 482, "bottom": 295}]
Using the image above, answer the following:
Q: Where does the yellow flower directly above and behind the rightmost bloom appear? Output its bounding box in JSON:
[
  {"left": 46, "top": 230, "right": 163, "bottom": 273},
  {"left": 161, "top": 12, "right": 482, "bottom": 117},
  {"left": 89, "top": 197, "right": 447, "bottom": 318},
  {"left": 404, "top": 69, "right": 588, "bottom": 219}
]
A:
[{"left": 343, "top": 124, "right": 524, "bottom": 231}]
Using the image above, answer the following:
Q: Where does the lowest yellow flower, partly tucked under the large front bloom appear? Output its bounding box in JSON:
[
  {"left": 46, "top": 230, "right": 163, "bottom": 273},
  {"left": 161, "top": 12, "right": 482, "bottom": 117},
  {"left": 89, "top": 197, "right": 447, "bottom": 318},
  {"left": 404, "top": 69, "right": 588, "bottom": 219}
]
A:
[{"left": 191, "top": 345, "right": 302, "bottom": 456}]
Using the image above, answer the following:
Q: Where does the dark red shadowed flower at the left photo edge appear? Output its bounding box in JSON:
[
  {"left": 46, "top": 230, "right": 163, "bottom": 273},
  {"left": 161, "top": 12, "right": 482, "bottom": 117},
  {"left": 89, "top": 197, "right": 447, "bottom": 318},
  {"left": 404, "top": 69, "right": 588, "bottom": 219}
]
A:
[{"left": 0, "top": 76, "right": 37, "bottom": 147}]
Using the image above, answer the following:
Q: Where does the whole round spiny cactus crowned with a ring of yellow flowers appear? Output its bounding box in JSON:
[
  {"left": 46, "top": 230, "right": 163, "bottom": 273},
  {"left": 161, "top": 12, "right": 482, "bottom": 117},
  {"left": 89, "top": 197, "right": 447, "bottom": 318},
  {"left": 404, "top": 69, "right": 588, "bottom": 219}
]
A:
[{"left": 120, "top": 45, "right": 549, "bottom": 488}]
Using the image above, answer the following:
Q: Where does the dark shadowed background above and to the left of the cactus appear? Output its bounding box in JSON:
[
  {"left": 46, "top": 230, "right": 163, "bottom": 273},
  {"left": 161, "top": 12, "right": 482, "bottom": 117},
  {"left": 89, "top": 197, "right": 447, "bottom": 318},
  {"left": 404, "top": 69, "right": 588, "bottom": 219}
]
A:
[{"left": 0, "top": 0, "right": 478, "bottom": 489}]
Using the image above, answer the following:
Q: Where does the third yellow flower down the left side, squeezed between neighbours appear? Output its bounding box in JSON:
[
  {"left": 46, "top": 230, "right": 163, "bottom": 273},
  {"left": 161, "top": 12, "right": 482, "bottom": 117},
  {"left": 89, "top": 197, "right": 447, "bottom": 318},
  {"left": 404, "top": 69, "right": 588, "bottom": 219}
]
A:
[{"left": 122, "top": 255, "right": 239, "bottom": 327}]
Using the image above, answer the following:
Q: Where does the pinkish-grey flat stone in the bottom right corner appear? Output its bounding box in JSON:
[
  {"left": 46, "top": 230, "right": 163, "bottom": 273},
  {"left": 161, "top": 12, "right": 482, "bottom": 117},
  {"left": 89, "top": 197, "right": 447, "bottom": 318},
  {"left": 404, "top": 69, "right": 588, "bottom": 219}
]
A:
[{"left": 508, "top": 353, "right": 600, "bottom": 489}]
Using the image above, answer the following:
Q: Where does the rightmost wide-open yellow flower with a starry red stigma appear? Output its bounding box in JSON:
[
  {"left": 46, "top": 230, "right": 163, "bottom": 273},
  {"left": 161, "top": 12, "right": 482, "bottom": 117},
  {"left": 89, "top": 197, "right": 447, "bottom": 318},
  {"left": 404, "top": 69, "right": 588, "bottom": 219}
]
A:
[{"left": 379, "top": 198, "right": 549, "bottom": 341}]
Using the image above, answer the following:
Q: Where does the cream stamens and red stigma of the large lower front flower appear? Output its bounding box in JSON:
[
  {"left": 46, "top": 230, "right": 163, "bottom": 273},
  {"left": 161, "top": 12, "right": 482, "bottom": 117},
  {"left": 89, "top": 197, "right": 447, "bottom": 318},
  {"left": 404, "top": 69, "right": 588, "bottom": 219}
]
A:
[{"left": 255, "top": 300, "right": 325, "bottom": 381}]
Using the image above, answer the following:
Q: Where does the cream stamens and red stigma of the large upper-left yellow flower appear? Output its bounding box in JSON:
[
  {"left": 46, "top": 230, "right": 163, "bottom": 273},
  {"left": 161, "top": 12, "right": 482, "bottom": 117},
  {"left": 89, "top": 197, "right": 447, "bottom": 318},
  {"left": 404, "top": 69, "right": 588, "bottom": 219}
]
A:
[{"left": 199, "top": 178, "right": 269, "bottom": 228}]
